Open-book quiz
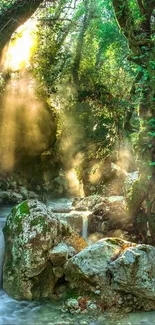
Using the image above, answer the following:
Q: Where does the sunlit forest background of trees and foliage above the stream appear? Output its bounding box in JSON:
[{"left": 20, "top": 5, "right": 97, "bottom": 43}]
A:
[{"left": 0, "top": 0, "right": 155, "bottom": 242}]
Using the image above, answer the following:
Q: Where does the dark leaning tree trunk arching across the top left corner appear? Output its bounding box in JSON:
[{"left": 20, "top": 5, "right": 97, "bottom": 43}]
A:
[{"left": 0, "top": 0, "right": 43, "bottom": 54}]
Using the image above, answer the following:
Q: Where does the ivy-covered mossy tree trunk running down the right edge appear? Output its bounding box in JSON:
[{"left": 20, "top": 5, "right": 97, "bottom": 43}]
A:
[{"left": 112, "top": 0, "right": 155, "bottom": 243}]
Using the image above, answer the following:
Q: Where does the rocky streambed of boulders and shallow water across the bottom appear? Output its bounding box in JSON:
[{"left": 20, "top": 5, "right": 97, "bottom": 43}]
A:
[{"left": 0, "top": 200, "right": 155, "bottom": 325}]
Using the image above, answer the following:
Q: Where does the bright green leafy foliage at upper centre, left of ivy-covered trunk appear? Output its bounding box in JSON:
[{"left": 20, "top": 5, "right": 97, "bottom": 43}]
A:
[{"left": 33, "top": 0, "right": 135, "bottom": 167}]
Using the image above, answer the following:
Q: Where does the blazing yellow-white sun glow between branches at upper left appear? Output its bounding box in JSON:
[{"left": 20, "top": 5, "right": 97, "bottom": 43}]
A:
[{"left": 5, "top": 19, "right": 36, "bottom": 71}]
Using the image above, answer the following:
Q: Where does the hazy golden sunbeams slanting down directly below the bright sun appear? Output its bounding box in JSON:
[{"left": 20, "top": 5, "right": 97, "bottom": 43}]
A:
[{"left": 0, "top": 71, "right": 52, "bottom": 171}]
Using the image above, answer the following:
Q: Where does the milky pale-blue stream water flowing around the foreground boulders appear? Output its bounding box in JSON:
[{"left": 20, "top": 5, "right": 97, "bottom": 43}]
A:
[{"left": 0, "top": 200, "right": 155, "bottom": 325}]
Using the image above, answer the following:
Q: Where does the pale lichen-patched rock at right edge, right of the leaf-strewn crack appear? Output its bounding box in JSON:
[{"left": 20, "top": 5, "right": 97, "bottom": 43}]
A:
[{"left": 109, "top": 244, "right": 155, "bottom": 301}]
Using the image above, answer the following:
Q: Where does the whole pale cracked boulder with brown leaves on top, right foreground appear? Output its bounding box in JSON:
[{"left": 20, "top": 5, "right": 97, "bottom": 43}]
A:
[{"left": 65, "top": 238, "right": 155, "bottom": 311}]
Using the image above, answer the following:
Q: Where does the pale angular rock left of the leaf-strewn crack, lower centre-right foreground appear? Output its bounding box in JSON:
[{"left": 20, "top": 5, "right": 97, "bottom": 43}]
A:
[{"left": 65, "top": 239, "right": 123, "bottom": 304}]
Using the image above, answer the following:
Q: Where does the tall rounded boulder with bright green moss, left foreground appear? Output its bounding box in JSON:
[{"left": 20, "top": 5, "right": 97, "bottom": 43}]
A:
[{"left": 3, "top": 200, "right": 87, "bottom": 300}]
